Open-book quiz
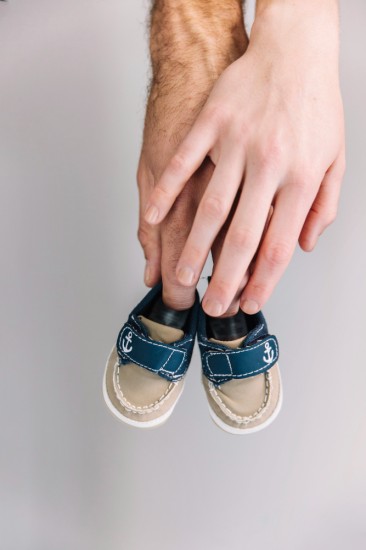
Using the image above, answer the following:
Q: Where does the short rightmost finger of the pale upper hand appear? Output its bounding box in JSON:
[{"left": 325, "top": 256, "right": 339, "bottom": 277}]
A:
[{"left": 299, "top": 154, "right": 345, "bottom": 252}]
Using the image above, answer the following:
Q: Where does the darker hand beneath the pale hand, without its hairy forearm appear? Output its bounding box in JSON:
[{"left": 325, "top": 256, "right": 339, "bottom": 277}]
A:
[{"left": 137, "top": 101, "right": 213, "bottom": 309}]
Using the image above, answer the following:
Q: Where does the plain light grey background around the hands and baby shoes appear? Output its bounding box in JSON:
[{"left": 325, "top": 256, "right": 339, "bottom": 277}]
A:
[{"left": 0, "top": 0, "right": 366, "bottom": 550}]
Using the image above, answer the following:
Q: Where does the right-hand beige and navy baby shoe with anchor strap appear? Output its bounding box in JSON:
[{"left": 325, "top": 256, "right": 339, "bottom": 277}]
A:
[{"left": 197, "top": 306, "right": 282, "bottom": 434}]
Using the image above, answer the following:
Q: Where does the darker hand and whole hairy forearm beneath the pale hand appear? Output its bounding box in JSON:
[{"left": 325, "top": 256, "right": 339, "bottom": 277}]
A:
[{"left": 137, "top": 0, "right": 247, "bottom": 309}]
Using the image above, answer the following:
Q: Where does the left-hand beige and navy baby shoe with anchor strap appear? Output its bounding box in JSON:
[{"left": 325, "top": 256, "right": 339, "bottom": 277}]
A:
[{"left": 103, "top": 282, "right": 199, "bottom": 428}]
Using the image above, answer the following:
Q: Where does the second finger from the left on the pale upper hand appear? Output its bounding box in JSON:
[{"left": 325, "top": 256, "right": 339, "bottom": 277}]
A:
[{"left": 177, "top": 147, "right": 244, "bottom": 285}]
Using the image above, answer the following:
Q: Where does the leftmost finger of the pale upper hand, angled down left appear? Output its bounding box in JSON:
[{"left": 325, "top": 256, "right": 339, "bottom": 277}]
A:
[{"left": 144, "top": 105, "right": 216, "bottom": 225}]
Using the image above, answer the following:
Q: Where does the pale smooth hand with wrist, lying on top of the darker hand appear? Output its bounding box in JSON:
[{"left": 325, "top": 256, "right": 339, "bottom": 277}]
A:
[{"left": 145, "top": 0, "right": 345, "bottom": 316}]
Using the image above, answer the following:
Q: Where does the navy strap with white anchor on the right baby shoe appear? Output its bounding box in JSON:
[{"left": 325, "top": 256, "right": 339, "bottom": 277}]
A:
[{"left": 202, "top": 336, "right": 279, "bottom": 384}]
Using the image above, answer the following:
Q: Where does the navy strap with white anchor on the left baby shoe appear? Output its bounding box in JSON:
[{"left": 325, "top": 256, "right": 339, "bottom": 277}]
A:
[{"left": 117, "top": 323, "right": 188, "bottom": 381}]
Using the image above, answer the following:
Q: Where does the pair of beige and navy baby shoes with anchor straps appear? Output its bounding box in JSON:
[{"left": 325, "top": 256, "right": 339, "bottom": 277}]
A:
[{"left": 103, "top": 282, "right": 282, "bottom": 434}]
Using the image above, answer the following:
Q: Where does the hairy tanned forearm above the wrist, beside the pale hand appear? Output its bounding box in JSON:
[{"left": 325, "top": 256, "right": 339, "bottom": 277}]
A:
[{"left": 145, "top": 0, "right": 248, "bottom": 142}]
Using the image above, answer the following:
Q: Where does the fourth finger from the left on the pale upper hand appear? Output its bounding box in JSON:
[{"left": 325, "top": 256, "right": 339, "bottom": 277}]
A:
[{"left": 240, "top": 183, "right": 313, "bottom": 315}]
